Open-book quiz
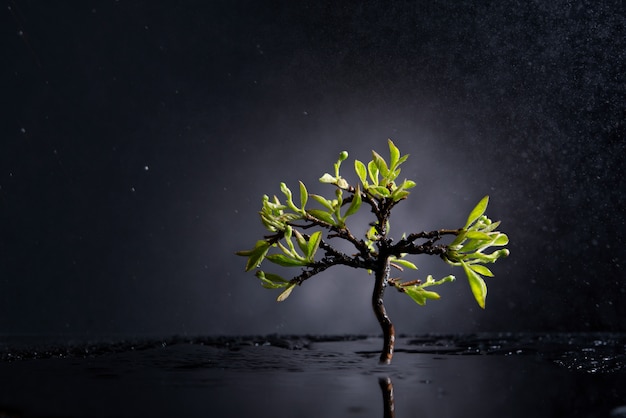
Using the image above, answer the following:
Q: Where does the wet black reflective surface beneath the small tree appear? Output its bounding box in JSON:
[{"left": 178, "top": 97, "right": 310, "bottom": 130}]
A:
[{"left": 0, "top": 333, "right": 626, "bottom": 417}]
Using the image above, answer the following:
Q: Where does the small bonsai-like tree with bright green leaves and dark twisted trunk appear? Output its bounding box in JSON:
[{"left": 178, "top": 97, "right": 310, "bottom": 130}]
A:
[{"left": 237, "top": 140, "right": 509, "bottom": 364}]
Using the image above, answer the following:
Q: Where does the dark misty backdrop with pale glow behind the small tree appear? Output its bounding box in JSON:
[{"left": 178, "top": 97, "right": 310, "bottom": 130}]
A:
[{"left": 0, "top": 0, "right": 626, "bottom": 335}]
